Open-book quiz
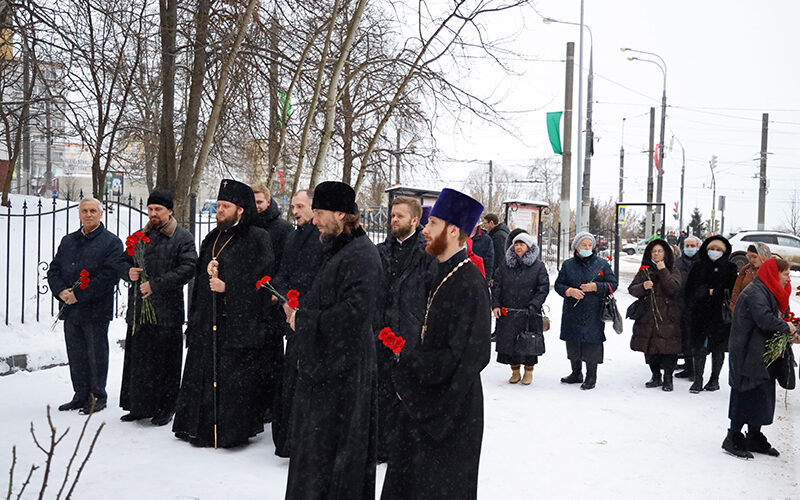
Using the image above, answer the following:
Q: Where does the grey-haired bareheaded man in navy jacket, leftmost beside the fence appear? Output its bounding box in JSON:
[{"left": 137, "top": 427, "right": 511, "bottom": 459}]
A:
[{"left": 47, "top": 198, "right": 123, "bottom": 413}]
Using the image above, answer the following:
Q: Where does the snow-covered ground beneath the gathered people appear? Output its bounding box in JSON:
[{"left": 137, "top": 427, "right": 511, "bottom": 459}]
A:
[{"left": 0, "top": 257, "right": 800, "bottom": 500}]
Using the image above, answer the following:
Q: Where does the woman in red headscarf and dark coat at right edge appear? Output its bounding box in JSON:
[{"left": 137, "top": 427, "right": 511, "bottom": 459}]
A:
[{"left": 722, "top": 257, "right": 800, "bottom": 458}]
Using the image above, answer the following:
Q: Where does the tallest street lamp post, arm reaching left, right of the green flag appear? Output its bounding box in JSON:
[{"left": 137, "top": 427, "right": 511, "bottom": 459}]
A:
[{"left": 542, "top": 9, "right": 594, "bottom": 231}]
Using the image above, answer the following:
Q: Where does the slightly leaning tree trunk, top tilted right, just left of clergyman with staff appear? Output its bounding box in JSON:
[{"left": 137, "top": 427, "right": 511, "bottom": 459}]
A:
[{"left": 175, "top": 0, "right": 211, "bottom": 221}]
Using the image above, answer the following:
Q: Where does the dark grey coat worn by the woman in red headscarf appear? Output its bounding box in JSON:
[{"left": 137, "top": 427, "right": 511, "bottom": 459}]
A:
[{"left": 728, "top": 278, "right": 789, "bottom": 392}]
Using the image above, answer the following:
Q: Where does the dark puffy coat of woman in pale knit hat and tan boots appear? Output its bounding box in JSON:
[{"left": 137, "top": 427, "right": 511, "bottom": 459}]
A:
[{"left": 492, "top": 246, "right": 550, "bottom": 356}]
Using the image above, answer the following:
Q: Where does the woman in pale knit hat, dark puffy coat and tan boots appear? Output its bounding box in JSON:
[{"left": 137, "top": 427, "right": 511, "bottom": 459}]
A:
[{"left": 492, "top": 233, "right": 550, "bottom": 385}]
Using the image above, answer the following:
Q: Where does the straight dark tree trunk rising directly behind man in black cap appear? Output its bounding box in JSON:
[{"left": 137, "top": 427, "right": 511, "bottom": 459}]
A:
[{"left": 156, "top": 0, "right": 178, "bottom": 189}]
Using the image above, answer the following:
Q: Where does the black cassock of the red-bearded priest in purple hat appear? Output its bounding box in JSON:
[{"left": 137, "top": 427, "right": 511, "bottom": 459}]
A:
[{"left": 381, "top": 249, "right": 491, "bottom": 500}]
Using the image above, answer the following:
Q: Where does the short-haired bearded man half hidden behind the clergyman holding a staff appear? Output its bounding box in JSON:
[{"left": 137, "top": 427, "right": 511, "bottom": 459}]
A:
[{"left": 251, "top": 184, "right": 292, "bottom": 422}]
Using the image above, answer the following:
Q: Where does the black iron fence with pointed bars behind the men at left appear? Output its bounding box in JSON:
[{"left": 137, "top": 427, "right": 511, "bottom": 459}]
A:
[{"left": 0, "top": 192, "right": 388, "bottom": 325}]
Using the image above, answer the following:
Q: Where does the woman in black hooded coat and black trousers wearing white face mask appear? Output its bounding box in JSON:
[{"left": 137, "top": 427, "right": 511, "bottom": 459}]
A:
[{"left": 684, "top": 236, "right": 737, "bottom": 394}]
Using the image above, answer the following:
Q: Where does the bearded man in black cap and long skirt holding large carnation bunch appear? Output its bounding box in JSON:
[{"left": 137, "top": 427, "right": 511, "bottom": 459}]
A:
[{"left": 119, "top": 189, "right": 197, "bottom": 426}]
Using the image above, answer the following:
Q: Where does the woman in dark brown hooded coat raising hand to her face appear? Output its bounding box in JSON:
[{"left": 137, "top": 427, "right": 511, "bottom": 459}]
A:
[{"left": 628, "top": 240, "right": 681, "bottom": 392}]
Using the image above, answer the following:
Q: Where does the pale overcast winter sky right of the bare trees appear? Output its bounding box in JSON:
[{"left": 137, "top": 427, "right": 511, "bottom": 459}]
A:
[{"left": 422, "top": 0, "right": 800, "bottom": 231}]
